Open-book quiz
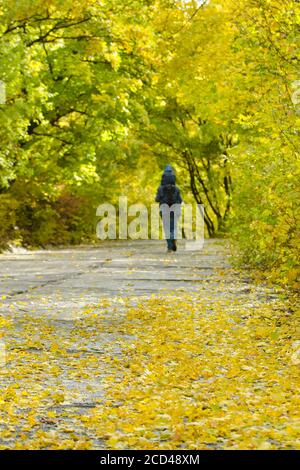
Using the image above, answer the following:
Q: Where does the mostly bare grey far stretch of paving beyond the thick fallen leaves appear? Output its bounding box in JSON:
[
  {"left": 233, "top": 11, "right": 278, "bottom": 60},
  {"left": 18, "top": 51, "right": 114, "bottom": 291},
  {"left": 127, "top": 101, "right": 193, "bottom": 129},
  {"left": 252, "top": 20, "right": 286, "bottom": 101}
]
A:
[{"left": 0, "top": 240, "right": 229, "bottom": 319}]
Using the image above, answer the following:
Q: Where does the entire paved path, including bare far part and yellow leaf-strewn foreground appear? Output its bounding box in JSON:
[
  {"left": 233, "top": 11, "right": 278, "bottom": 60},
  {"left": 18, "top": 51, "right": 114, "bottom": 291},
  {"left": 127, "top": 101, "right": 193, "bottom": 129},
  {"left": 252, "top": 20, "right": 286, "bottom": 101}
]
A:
[{"left": 0, "top": 240, "right": 299, "bottom": 449}]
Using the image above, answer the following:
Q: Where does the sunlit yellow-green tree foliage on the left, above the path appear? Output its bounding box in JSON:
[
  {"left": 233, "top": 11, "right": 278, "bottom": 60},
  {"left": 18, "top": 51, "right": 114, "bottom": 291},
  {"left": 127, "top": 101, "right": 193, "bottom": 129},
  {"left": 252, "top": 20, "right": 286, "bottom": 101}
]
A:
[{"left": 0, "top": 1, "right": 157, "bottom": 246}]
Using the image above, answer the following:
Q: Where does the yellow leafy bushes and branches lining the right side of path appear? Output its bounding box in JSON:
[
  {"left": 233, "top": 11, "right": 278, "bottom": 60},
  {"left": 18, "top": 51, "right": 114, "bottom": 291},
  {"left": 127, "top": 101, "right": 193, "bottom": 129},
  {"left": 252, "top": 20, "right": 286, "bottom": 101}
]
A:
[{"left": 225, "top": 0, "right": 300, "bottom": 287}]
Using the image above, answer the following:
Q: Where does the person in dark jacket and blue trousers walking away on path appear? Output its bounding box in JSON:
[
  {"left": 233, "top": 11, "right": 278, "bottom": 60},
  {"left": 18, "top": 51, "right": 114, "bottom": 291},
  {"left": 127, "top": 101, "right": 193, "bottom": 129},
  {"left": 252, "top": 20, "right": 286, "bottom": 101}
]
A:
[{"left": 155, "top": 165, "right": 182, "bottom": 252}]
